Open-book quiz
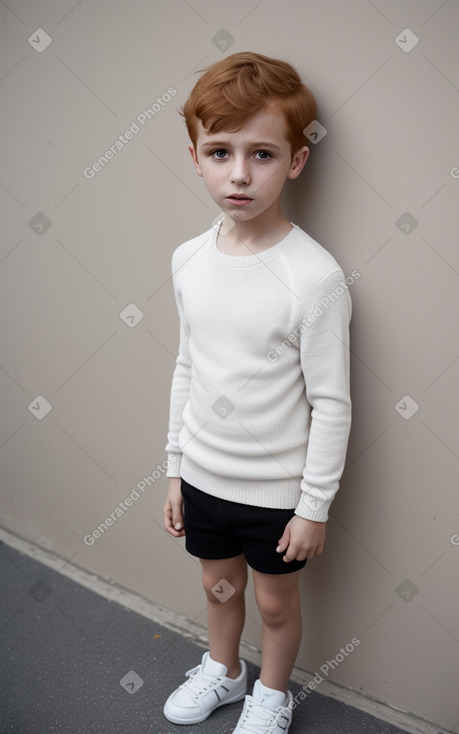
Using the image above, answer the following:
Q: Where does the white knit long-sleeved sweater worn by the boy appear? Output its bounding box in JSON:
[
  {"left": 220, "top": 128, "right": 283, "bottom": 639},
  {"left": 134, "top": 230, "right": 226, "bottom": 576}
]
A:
[{"left": 166, "top": 223, "right": 352, "bottom": 521}]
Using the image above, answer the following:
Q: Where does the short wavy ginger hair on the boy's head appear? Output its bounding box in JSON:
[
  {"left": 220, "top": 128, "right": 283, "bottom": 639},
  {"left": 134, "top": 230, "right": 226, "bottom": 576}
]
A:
[{"left": 179, "top": 51, "right": 317, "bottom": 161}]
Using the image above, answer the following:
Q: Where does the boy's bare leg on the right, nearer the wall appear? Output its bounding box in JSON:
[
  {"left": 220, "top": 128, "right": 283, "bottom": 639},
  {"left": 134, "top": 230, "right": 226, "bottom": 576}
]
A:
[{"left": 253, "top": 571, "right": 302, "bottom": 693}]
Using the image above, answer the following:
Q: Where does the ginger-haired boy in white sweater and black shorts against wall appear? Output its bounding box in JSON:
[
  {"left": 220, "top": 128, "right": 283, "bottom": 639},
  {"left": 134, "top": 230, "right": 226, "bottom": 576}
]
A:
[{"left": 164, "top": 52, "right": 351, "bottom": 734}]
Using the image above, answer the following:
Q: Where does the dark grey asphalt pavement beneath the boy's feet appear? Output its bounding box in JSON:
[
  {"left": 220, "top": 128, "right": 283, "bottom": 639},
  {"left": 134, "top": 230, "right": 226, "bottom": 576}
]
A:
[{"left": 0, "top": 536, "right": 446, "bottom": 734}]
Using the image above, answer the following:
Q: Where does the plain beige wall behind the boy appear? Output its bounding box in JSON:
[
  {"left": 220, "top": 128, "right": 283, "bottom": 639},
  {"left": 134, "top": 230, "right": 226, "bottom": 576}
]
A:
[{"left": 0, "top": 0, "right": 459, "bottom": 731}]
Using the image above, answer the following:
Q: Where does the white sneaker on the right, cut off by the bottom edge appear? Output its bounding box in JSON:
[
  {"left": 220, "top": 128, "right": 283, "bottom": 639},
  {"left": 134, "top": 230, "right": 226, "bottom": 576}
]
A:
[{"left": 233, "top": 680, "right": 293, "bottom": 734}]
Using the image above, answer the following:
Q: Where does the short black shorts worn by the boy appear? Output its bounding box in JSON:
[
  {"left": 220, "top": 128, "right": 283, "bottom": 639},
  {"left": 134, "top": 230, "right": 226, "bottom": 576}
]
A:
[{"left": 181, "top": 479, "right": 306, "bottom": 573}]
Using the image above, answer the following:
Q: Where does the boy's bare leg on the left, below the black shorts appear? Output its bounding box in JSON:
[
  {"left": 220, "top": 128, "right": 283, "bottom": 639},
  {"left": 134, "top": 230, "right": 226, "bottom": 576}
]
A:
[{"left": 200, "top": 555, "right": 247, "bottom": 678}]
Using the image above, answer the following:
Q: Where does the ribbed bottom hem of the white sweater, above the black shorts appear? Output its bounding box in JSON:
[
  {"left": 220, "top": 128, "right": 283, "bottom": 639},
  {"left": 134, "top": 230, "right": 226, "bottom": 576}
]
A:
[{"left": 180, "top": 455, "right": 301, "bottom": 510}]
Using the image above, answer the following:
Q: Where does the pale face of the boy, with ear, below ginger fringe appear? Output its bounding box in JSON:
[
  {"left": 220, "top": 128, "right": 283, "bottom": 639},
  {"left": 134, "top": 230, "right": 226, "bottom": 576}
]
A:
[{"left": 189, "top": 106, "right": 309, "bottom": 226}]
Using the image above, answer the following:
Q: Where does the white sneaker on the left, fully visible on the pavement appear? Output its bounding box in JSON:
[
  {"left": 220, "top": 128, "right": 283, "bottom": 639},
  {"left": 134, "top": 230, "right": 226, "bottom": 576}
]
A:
[{"left": 163, "top": 652, "right": 247, "bottom": 724}]
